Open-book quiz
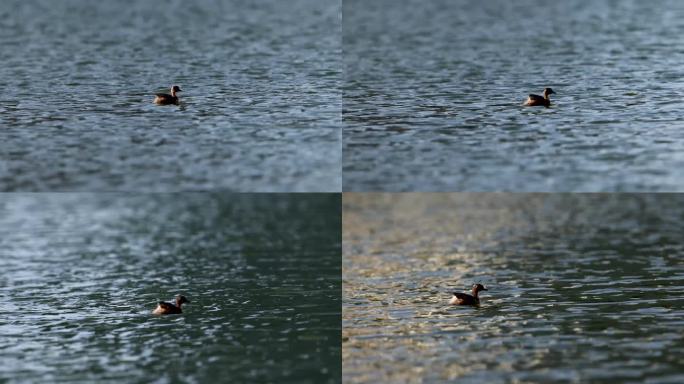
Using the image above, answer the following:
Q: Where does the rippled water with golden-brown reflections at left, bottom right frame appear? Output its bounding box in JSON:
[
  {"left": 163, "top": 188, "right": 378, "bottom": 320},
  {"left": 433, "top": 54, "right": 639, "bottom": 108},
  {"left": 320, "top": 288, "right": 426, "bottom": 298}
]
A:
[{"left": 342, "top": 194, "right": 684, "bottom": 383}]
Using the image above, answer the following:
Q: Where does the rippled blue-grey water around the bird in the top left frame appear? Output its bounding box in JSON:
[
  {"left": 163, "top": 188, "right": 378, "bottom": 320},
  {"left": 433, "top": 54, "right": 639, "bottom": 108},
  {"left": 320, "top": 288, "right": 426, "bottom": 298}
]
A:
[{"left": 0, "top": 0, "right": 341, "bottom": 192}]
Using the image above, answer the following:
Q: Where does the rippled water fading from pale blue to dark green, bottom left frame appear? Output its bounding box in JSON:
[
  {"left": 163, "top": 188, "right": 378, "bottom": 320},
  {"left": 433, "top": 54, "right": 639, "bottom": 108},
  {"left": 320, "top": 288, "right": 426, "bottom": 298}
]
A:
[{"left": 0, "top": 194, "right": 341, "bottom": 384}]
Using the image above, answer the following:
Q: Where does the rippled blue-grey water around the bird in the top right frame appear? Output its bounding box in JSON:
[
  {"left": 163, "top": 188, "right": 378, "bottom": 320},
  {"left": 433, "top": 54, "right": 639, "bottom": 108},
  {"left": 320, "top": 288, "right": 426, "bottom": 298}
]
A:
[{"left": 343, "top": 0, "right": 684, "bottom": 192}]
